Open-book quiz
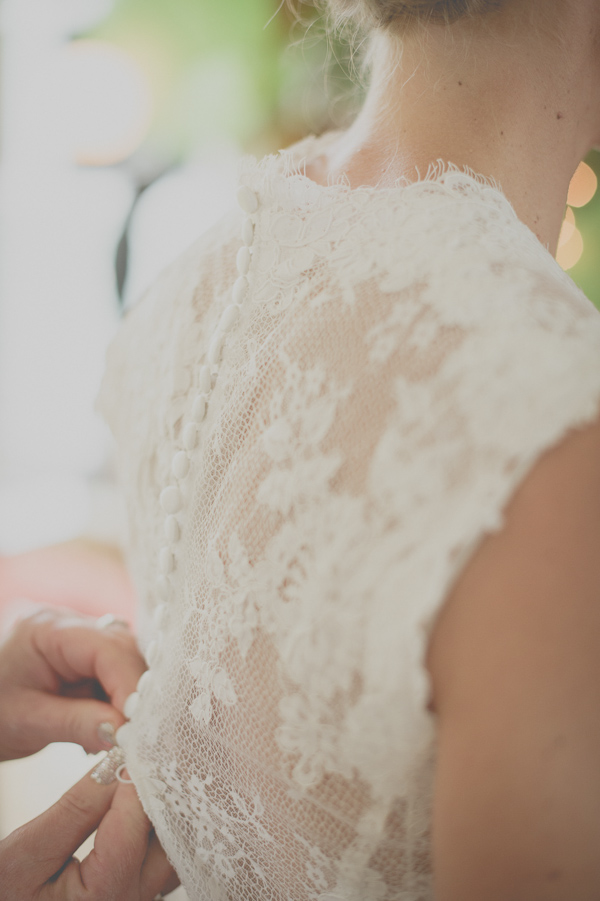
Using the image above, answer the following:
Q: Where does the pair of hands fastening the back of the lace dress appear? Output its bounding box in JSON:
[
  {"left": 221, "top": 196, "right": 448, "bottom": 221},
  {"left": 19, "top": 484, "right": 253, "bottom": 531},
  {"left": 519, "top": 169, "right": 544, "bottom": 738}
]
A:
[{"left": 0, "top": 611, "right": 177, "bottom": 901}]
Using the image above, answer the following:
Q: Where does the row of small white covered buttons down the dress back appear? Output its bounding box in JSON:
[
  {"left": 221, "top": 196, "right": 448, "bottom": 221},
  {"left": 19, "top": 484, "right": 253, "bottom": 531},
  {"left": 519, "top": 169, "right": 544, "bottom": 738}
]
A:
[{"left": 122, "top": 186, "right": 259, "bottom": 728}]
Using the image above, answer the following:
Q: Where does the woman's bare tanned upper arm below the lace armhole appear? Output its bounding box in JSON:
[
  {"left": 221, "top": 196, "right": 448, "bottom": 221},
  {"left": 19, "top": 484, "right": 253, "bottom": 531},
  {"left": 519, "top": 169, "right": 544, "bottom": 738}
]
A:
[{"left": 428, "top": 419, "right": 600, "bottom": 901}]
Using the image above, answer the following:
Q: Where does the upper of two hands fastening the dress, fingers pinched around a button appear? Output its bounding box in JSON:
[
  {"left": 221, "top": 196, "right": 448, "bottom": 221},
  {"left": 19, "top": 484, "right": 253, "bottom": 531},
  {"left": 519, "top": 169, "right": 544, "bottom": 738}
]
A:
[{"left": 0, "top": 611, "right": 146, "bottom": 760}]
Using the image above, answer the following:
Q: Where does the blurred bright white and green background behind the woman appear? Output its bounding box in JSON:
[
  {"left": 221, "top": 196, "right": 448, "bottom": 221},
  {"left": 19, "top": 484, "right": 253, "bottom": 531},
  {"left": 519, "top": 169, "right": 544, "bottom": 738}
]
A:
[{"left": 0, "top": 0, "right": 600, "bottom": 864}]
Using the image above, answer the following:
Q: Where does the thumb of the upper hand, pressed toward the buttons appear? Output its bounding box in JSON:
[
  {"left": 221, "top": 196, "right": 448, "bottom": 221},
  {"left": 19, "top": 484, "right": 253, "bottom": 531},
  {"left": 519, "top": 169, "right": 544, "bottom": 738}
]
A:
[{"left": 28, "top": 695, "right": 125, "bottom": 754}]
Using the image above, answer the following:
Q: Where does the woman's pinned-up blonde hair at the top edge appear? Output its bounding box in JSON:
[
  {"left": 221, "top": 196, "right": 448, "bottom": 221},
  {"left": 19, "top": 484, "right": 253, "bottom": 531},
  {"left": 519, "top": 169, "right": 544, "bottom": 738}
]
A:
[{"left": 328, "top": 0, "right": 505, "bottom": 31}]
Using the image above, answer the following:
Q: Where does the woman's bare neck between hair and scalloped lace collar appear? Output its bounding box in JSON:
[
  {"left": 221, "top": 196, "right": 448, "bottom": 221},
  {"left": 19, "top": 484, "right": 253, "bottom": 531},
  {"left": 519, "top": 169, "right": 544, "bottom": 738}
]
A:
[{"left": 312, "top": 9, "right": 600, "bottom": 255}]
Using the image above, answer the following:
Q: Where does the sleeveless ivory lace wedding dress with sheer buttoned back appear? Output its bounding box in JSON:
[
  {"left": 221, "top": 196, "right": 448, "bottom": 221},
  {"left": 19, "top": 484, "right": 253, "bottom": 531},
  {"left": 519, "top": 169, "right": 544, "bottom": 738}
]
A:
[{"left": 100, "top": 130, "right": 600, "bottom": 901}]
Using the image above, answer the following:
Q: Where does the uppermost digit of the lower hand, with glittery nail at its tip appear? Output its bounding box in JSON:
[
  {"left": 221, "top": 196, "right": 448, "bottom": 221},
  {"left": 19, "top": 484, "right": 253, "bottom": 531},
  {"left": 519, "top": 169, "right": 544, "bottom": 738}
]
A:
[{"left": 0, "top": 775, "right": 116, "bottom": 898}]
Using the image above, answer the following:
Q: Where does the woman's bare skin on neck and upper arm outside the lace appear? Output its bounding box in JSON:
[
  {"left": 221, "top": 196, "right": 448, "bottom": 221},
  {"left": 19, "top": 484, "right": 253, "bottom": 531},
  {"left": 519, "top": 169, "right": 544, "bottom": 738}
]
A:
[{"left": 308, "top": 0, "right": 600, "bottom": 901}]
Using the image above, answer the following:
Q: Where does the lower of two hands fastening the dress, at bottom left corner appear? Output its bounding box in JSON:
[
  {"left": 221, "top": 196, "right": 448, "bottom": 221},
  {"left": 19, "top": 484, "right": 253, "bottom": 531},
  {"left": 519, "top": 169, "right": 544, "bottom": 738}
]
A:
[{"left": 0, "top": 775, "right": 178, "bottom": 901}]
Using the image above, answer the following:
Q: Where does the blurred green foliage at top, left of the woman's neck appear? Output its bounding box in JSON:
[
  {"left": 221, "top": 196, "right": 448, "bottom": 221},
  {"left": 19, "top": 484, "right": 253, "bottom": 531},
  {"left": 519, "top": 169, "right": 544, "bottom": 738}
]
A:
[{"left": 88, "top": 0, "right": 354, "bottom": 160}]
